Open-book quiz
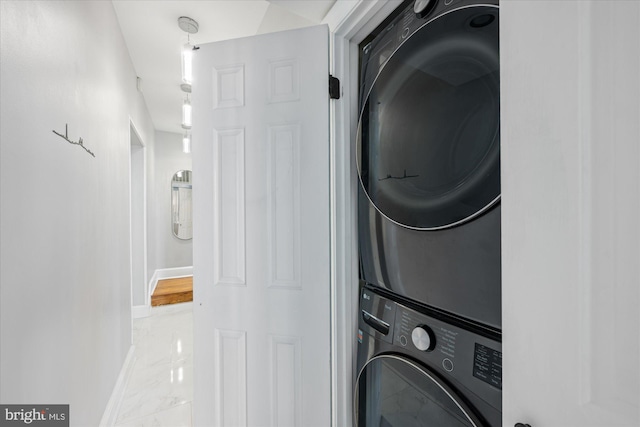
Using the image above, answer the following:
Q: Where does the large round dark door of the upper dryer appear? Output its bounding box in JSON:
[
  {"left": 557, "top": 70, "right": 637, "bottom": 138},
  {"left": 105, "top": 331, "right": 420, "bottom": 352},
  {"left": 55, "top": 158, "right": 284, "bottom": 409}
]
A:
[{"left": 356, "top": 6, "right": 500, "bottom": 230}]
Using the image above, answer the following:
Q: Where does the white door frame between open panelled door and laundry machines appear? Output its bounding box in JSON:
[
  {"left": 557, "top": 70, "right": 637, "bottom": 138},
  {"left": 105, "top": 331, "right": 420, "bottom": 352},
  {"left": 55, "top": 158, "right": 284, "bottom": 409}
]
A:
[{"left": 323, "top": 0, "right": 403, "bottom": 427}]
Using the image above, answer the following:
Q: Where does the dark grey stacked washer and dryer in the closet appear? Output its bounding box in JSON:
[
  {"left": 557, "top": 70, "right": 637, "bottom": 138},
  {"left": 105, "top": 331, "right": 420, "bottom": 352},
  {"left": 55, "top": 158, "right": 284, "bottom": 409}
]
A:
[{"left": 354, "top": 0, "right": 502, "bottom": 427}]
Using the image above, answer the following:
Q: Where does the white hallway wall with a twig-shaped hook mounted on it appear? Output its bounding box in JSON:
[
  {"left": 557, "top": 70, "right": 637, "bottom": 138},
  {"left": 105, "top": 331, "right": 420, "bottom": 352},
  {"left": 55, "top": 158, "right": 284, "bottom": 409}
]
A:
[{"left": 0, "top": 1, "right": 154, "bottom": 426}]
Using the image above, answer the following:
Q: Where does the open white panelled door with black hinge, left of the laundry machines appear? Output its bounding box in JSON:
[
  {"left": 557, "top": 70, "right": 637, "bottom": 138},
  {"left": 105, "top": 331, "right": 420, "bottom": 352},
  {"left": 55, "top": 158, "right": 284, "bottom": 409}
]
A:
[{"left": 192, "top": 26, "right": 330, "bottom": 427}]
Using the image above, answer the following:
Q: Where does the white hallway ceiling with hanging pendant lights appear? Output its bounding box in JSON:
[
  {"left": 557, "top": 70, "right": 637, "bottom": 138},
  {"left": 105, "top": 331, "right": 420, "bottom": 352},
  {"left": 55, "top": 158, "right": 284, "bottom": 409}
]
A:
[{"left": 112, "top": 0, "right": 336, "bottom": 133}]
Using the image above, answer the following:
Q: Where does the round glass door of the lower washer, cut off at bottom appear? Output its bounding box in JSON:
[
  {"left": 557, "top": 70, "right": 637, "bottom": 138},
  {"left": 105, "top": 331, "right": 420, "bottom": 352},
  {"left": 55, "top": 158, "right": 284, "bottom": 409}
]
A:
[{"left": 354, "top": 355, "right": 483, "bottom": 427}]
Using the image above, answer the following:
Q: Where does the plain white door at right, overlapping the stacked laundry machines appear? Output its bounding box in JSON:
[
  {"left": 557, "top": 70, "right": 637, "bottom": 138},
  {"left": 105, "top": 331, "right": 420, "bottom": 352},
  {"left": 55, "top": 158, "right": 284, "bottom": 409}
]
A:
[{"left": 500, "top": 1, "right": 640, "bottom": 427}]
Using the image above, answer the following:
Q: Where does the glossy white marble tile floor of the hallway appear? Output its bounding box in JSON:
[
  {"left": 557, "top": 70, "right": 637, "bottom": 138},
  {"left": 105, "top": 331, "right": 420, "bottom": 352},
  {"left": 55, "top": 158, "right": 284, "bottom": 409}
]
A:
[{"left": 115, "top": 303, "right": 193, "bottom": 427}]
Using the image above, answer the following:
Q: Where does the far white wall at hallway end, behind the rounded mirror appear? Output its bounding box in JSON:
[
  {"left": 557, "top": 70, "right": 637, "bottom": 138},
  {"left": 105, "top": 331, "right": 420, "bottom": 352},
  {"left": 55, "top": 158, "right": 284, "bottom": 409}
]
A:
[{"left": 153, "top": 132, "right": 193, "bottom": 273}]
